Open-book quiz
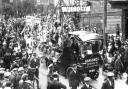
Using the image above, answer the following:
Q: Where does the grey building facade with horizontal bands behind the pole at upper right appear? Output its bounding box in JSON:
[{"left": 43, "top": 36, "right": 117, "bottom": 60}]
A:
[{"left": 81, "top": 0, "right": 122, "bottom": 34}]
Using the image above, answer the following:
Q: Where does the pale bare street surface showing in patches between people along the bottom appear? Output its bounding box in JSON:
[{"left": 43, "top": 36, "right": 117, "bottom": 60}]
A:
[{"left": 39, "top": 55, "right": 128, "bottom": 89}]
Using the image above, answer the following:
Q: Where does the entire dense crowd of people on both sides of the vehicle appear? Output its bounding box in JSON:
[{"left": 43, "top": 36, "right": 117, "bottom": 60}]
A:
[{"left": 0, "top": 12, "right": 128, "bottom": 89}]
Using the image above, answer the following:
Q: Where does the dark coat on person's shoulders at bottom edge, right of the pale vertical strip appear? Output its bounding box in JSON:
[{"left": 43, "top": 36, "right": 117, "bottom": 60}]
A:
[{"left": 47, "top": 81, "right": 66, "bottom": 89}]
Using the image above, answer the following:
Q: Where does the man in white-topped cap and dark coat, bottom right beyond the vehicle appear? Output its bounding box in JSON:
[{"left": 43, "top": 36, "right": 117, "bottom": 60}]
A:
[{"left": 101, "top": 72, "right": 115, "bottom": 89}]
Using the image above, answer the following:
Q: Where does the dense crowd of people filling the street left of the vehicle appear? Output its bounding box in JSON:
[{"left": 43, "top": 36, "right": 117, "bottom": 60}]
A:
[{"left": 0, "top": 14, "right": 77, "bottom": 89}]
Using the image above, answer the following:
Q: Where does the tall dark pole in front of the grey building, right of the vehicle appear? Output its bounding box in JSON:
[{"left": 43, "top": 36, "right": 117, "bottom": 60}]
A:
[{"left": 103, "top": 0, "right": 107, "bottom": 47}]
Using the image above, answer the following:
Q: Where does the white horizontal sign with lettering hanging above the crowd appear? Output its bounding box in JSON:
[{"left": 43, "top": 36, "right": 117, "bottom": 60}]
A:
[{"left": 62, "top": 6, "right": 90, "bottom": 12}]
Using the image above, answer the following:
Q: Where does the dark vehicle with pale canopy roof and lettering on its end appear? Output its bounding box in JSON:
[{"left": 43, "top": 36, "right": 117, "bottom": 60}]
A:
[{"left": 57, "top": 31, "right": 102, "bottom": 79}]
